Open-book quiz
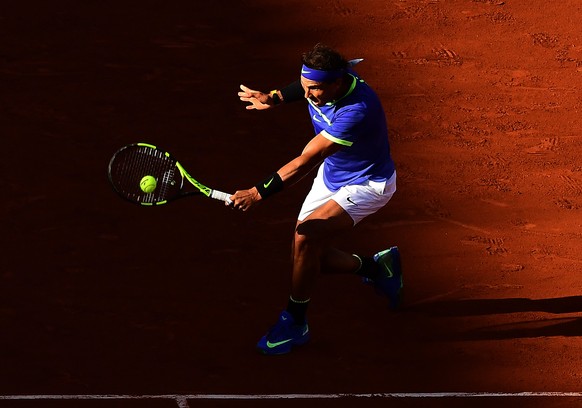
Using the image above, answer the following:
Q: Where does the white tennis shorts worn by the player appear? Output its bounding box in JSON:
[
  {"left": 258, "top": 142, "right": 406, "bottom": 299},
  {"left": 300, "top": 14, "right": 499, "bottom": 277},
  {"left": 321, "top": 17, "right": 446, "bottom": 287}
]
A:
[{"left": 297, "top": 164, "right": 396, "bottom": 225}]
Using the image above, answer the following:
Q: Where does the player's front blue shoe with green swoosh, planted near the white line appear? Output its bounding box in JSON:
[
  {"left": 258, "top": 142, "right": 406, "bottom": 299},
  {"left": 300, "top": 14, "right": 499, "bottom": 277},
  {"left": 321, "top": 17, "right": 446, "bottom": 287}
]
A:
[{"left": 257, "top": 311, "right": 309, "bottom": 355}]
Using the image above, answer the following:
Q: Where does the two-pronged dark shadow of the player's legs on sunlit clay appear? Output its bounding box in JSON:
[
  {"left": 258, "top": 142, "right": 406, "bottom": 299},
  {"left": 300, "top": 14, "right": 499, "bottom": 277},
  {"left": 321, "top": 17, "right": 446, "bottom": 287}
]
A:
[{"left": 411, "top": 296, "right": 582, "bottom": 340}]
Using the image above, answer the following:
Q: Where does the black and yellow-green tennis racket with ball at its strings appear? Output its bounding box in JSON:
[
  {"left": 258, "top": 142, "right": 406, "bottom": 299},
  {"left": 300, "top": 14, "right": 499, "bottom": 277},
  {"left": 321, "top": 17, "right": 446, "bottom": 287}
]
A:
[{"left": 108, "top": 143, "right": 232, "bottom": 206}]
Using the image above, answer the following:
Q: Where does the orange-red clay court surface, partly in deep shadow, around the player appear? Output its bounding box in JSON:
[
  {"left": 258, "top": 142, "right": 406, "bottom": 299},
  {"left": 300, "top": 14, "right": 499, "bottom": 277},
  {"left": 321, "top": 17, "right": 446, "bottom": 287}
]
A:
[{"left": 0, "top": 0, "right": 582, "bottom": 408}]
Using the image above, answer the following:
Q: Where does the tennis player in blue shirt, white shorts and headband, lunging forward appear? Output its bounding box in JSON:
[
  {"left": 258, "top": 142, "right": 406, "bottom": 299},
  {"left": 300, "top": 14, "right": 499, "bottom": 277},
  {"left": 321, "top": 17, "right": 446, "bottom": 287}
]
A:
[{"left": 230, "top": 44, "right": 402, "bottom": 355}]
